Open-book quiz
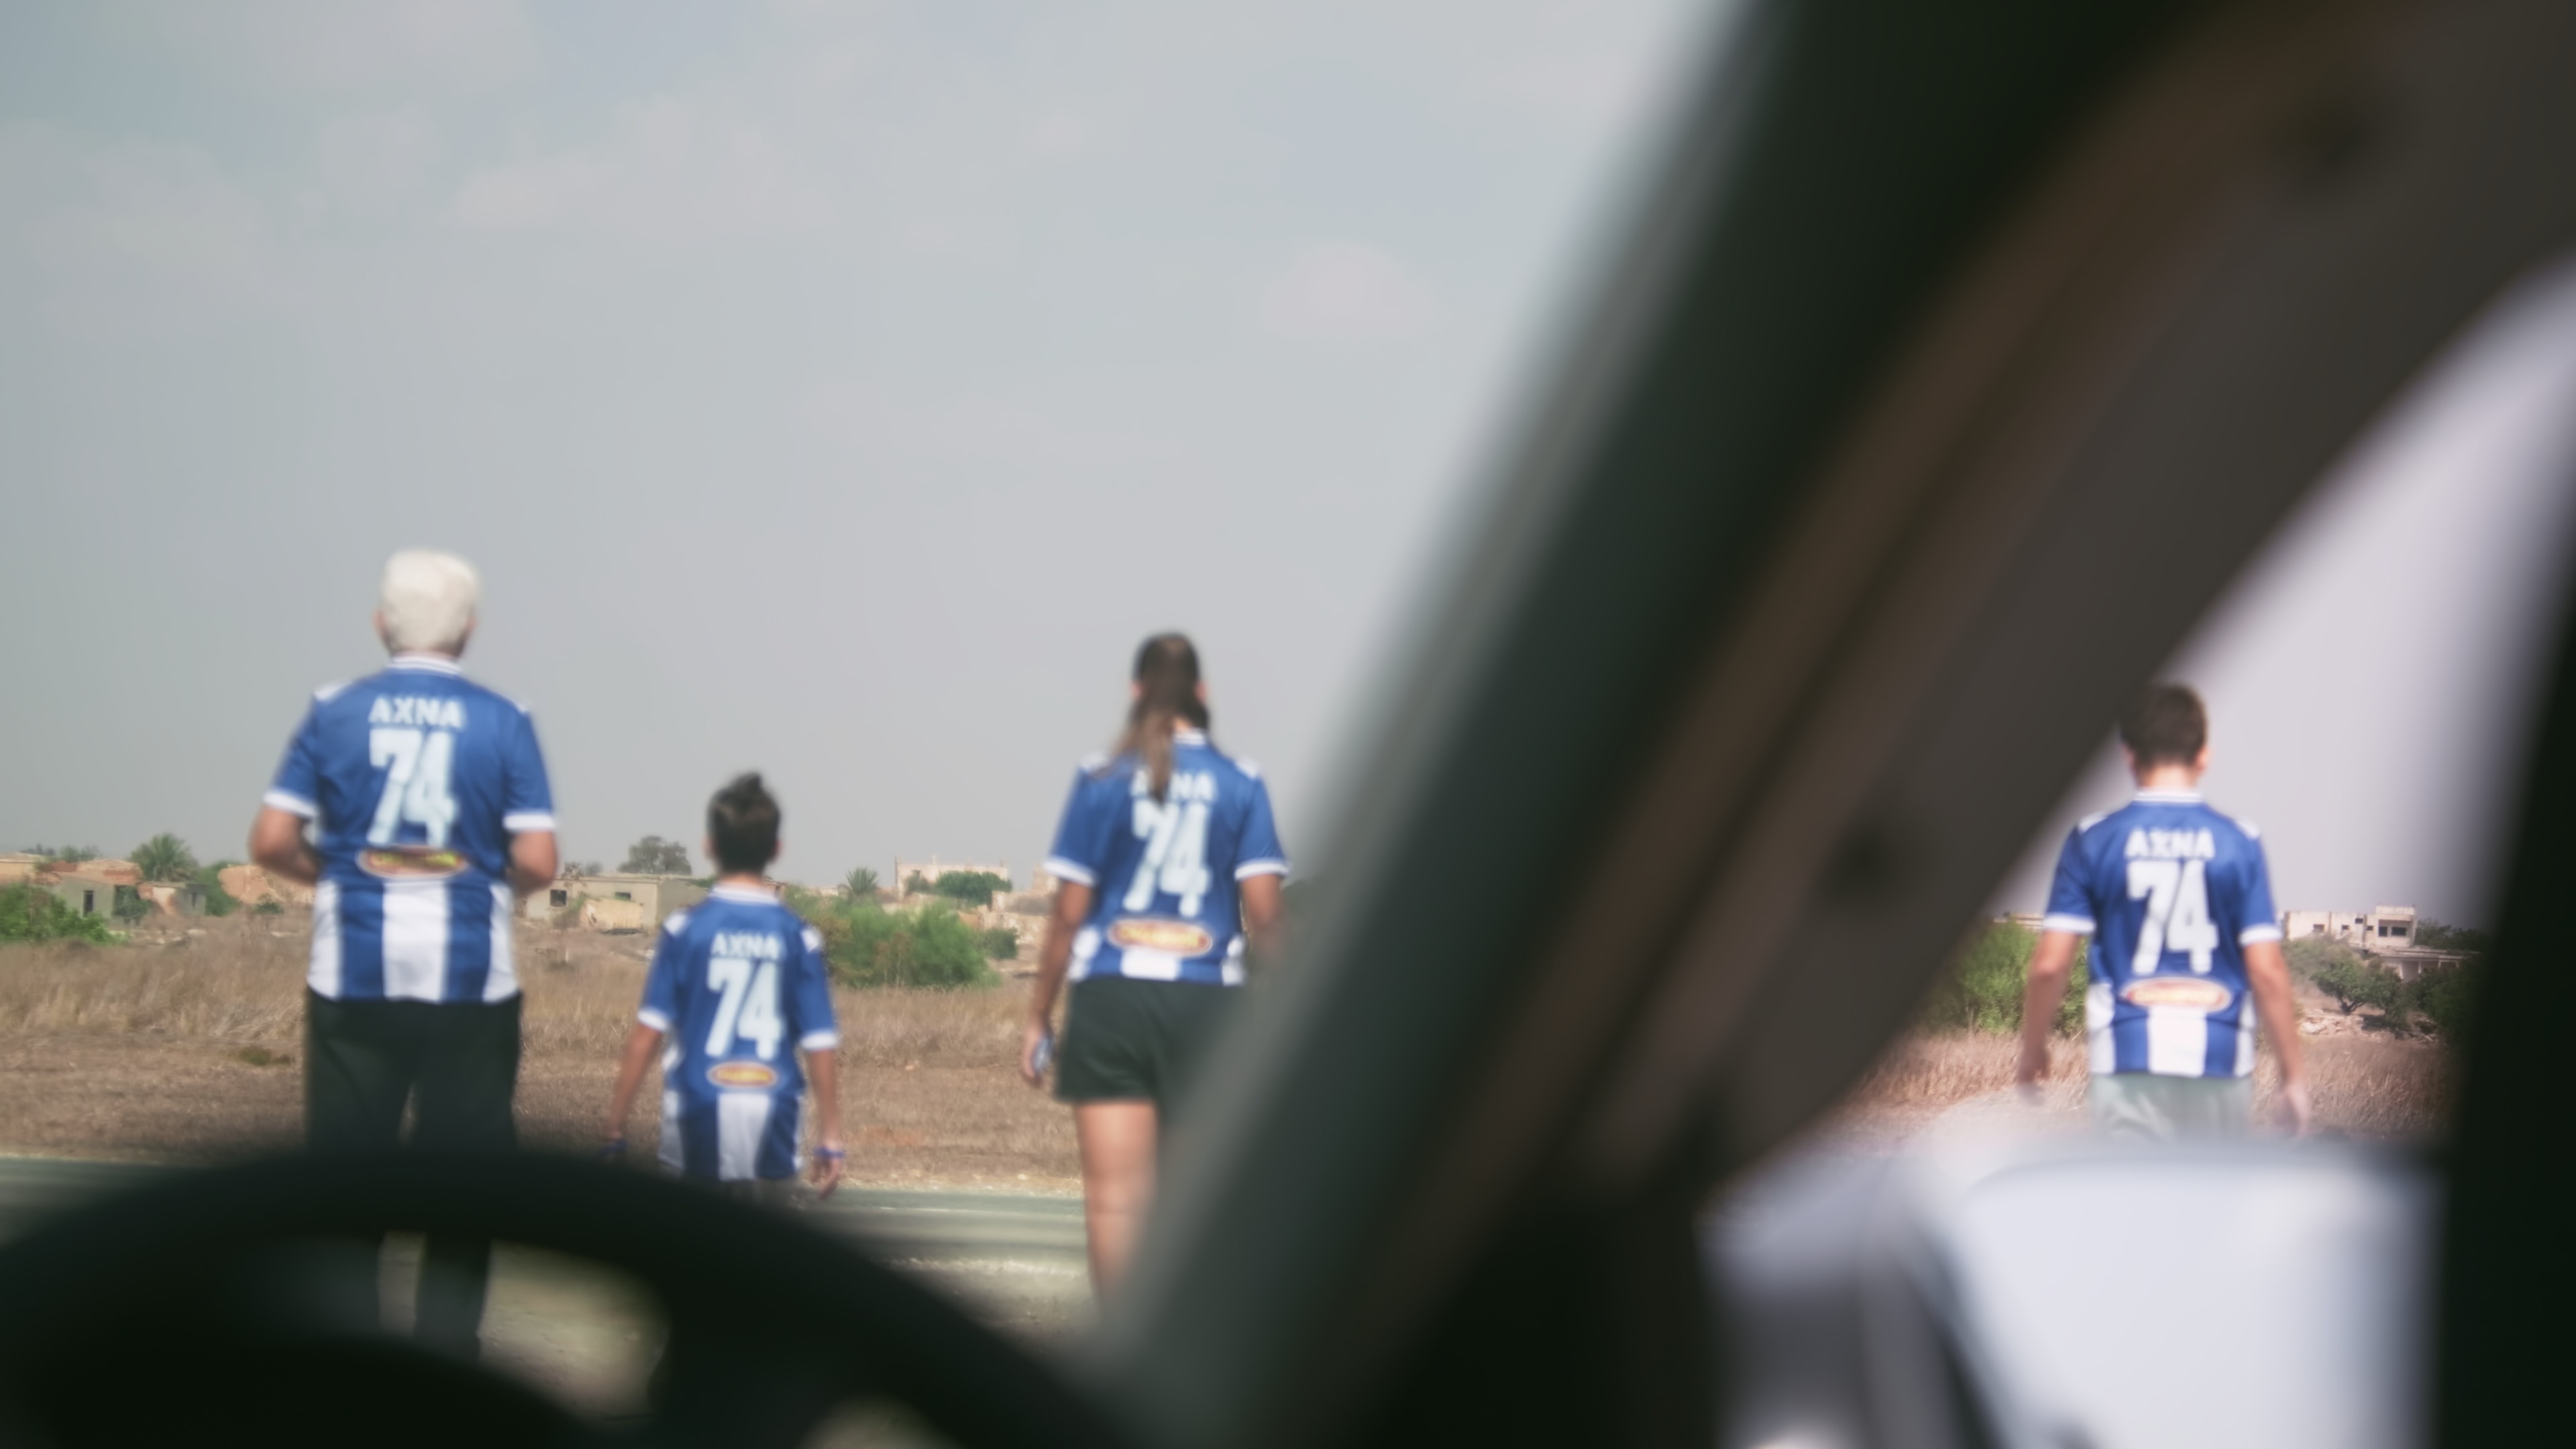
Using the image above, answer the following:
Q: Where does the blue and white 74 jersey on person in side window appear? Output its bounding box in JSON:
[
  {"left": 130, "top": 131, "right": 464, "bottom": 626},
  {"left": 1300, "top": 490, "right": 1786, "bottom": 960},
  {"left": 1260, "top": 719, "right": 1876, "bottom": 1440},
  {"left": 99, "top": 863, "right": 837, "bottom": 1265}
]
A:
[{"left": 2043, "top": 789, "right": 2279, "bottom": 1078}]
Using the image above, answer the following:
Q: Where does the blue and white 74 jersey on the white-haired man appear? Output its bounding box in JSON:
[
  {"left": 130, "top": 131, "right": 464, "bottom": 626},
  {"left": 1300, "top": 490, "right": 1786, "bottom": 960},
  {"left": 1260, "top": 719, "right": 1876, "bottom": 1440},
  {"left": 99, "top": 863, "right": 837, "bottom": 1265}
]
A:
[{"left": 263, "top": 655, "right": 554, "bottom": 1000}]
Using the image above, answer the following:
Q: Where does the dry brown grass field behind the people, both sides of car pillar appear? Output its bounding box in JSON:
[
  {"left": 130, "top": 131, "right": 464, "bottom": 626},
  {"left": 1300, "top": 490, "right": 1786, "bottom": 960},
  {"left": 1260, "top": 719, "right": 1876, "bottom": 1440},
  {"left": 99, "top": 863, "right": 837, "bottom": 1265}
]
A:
[{"left": 0, "top": 915, "right": 2453, "bottom": 1175}]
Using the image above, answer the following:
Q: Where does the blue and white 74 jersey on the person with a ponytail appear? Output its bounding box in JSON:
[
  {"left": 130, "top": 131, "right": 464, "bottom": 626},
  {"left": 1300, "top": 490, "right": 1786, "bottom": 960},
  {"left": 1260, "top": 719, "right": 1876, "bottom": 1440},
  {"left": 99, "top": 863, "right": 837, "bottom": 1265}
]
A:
[{"left": 1046, "top": 730, "right": 1288, "bottom": 985}]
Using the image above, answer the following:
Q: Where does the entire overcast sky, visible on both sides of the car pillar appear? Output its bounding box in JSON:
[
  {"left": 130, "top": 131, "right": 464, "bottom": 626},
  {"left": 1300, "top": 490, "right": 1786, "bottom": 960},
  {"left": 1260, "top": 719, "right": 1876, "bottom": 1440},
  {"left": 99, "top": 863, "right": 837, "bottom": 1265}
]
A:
[{"left": 0, "top": 0, "right": 2576, "bottom": 920}]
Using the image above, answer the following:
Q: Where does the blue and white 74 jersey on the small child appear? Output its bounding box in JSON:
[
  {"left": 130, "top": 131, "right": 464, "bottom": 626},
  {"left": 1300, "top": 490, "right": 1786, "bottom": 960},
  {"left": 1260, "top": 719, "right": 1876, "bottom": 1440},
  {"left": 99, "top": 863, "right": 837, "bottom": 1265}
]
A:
[{"left": 636, "top": 884, "right": 840, "bottom": 1183}]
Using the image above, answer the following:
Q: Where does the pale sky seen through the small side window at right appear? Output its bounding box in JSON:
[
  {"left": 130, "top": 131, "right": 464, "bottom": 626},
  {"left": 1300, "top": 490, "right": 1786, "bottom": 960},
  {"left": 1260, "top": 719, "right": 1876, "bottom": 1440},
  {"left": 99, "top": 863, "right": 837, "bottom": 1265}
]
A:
[{"left": 1999, "top": 263, "right": 2576, "bottom": 926}]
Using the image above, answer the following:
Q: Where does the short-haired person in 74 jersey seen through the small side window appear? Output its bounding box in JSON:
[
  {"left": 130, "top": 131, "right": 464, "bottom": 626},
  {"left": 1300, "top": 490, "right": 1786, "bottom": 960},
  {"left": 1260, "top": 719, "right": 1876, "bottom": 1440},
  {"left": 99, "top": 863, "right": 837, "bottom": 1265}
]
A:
[{"left": 2017, "top": 684, "right": 2308, "bottom": 1140}]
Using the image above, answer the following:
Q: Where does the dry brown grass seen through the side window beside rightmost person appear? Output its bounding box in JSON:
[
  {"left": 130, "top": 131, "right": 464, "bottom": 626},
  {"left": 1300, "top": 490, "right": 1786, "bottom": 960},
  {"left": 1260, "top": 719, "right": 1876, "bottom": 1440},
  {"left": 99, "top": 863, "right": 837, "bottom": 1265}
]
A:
[{"left": 1824, "top": 1034, "right": 2455, "bottom": 1142}]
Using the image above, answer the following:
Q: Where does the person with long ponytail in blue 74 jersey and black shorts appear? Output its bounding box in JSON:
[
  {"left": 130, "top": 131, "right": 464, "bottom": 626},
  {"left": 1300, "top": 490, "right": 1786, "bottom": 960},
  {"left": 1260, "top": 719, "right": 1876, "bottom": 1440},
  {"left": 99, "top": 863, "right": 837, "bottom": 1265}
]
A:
[{"left": 1020, "top": 634, "right": 1288, "bottom": 1292}]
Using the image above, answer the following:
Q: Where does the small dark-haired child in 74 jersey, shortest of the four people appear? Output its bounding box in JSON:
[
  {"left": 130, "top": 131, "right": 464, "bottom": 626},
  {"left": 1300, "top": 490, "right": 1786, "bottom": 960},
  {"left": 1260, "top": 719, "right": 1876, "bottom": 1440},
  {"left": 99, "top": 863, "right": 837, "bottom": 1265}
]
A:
[{"left": 608, "top": 773, "right": 847, "bottom": 1201}]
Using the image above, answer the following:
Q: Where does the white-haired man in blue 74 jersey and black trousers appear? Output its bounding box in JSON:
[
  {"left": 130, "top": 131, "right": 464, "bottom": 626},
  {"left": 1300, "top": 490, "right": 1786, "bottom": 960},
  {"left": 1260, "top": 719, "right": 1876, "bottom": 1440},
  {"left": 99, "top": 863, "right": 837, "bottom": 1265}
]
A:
[{"left": 250, "top": 549, "right": 554, "bottom": 1354}]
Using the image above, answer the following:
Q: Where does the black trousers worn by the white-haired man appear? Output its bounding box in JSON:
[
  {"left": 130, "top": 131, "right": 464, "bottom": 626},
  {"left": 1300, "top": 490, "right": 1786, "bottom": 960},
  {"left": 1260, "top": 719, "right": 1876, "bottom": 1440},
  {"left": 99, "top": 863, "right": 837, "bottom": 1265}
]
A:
[{"left": 304, "top": 993, "right": 521, "bottom": 1356}]
